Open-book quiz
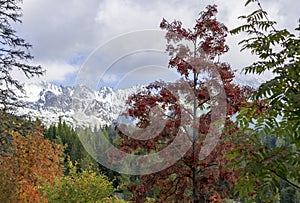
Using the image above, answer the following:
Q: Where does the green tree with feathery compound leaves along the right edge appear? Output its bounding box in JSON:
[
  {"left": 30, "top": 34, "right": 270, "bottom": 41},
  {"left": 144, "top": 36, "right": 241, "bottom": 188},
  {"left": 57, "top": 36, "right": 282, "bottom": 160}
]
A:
[{"left": 231, "top": 0, "right": 300, "bottom": 201}]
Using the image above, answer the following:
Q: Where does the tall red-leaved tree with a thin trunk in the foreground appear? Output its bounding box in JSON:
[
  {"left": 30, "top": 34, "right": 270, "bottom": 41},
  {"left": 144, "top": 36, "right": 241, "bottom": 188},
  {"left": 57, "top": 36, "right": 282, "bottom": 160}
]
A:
[{"left": 118, "top": 5, "right": 251, "bottom": 202}]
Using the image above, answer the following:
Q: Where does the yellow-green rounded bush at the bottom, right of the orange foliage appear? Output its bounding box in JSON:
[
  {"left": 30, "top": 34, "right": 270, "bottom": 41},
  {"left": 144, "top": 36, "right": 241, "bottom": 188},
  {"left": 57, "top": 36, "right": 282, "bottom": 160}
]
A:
[{"left": 41, "top": 162, "right": 122, "bottom": 203}]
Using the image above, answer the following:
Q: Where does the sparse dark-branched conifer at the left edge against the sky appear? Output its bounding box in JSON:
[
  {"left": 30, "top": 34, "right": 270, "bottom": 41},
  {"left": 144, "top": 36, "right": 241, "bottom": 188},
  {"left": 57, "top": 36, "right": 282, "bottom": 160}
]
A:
[{"left": 0, "top": 0, "right": 43, "bottom": 110}]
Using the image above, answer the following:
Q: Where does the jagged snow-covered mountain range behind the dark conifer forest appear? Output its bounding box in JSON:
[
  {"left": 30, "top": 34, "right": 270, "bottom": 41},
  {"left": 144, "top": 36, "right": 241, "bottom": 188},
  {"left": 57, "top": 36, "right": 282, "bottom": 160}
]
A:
[{"left": 18, "top": 82, "right": 143, "bottom": 127}]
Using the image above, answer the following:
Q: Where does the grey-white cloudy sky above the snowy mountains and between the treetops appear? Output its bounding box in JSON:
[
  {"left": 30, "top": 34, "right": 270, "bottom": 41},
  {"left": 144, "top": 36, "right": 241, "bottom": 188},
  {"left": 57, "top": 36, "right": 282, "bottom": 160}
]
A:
[{"left": 15, "top": 0, "right": 300, "bottom": 88}]
